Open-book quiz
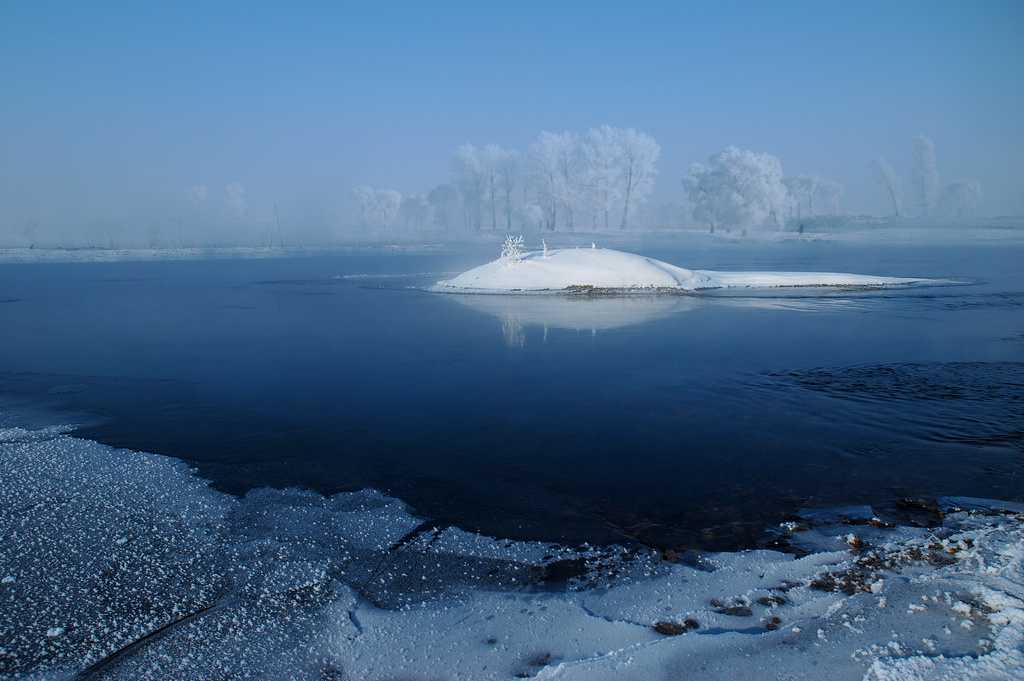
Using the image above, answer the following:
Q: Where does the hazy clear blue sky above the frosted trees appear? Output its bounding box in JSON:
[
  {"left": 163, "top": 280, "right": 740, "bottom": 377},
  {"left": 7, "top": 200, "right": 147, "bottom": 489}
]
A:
[{"left": 0, "top": 0, "right": 1024, "bottom": 229}]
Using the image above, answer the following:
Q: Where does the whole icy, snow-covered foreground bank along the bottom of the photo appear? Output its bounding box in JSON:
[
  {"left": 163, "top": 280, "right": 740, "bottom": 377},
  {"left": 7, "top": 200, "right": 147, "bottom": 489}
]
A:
[{"left": 0, "top": 427, "right": 1024, "bottom": 681}]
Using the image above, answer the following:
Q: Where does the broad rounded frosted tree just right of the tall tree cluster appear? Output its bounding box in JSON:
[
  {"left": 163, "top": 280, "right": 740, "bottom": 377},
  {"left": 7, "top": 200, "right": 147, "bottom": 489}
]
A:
[{"left": 683, "top": 146, "right": 790, "bottom": 231}]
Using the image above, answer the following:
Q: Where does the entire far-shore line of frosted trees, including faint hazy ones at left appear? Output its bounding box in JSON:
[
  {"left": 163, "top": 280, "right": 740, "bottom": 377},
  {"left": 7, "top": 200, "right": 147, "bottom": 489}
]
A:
[{"left": 0, "top": 131, "right": 982, "bottom": 248}]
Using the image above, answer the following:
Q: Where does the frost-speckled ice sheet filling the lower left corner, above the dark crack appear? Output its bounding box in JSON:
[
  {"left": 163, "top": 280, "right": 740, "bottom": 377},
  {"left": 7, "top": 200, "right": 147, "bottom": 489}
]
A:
[{"left": 0, "top": 428, "right": 229, "bottom": 676}]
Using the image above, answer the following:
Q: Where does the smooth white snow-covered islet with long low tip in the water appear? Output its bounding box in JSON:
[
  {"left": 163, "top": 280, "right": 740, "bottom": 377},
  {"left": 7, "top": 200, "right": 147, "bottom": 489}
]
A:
[{"left": 432, "top": 248, "right": 923, "bottom": 293}]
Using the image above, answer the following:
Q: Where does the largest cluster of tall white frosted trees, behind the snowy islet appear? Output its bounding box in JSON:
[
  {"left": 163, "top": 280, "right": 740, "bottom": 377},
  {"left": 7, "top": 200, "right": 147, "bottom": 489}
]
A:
[{"left": 349, "top": 125, "right": 660, "bottom": 230}]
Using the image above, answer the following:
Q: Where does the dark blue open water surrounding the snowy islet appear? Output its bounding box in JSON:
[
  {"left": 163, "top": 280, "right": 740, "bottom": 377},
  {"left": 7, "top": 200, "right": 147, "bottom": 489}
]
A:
[{"left": 0, "top": 237, "right": 1024, "bottom": 548}]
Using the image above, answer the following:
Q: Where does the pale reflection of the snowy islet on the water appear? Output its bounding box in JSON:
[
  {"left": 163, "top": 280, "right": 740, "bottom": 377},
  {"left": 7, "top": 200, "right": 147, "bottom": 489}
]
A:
[{"left": 451, "top": 295, "right": 698, "bottom": 347}]
